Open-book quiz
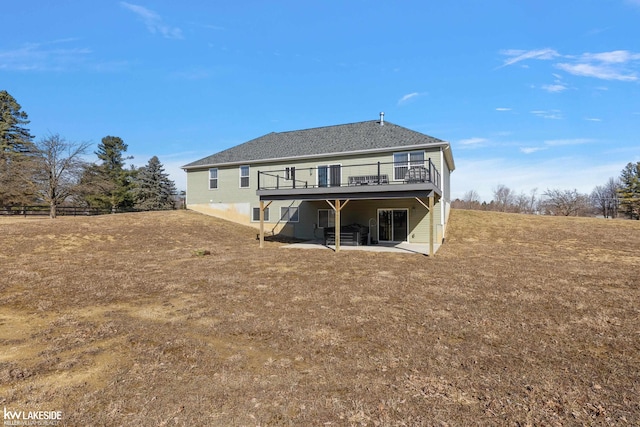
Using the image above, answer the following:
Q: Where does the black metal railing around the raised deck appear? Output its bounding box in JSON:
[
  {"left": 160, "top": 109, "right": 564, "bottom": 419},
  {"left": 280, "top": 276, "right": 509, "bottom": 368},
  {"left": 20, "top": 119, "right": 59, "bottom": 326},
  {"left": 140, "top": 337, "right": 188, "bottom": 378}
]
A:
[{"left": 258, "top": 159, "right": 441, "bottom": 190}]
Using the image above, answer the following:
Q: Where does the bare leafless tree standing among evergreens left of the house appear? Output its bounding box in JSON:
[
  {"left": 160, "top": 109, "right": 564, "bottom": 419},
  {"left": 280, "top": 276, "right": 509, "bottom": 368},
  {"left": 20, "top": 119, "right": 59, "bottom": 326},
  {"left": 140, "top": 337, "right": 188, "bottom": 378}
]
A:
[{"left": 35, "top": 134, "right": 90, "bottom": 218}]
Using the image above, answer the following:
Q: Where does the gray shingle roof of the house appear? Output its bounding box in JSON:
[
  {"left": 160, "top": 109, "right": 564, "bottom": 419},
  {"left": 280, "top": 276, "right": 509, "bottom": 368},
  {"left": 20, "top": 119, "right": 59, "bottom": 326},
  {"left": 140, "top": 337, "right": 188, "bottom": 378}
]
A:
[{"left": 183, "top": 120, "right": 447, "bottom": 169}]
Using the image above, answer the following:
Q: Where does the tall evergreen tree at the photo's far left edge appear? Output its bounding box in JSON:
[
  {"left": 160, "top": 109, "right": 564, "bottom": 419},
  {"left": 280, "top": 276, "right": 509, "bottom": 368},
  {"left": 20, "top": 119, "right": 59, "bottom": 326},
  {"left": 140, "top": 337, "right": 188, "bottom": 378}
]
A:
[{"left": 0, "top": 90, "right": 34, "bottom": 206}]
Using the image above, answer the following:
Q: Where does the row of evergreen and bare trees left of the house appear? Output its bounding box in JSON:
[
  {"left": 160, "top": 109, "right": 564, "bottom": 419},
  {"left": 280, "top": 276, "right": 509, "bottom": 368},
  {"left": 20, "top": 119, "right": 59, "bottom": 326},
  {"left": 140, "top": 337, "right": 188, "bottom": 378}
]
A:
[{"left": 0, "top": 90, "right": 176, "bottom": 218}]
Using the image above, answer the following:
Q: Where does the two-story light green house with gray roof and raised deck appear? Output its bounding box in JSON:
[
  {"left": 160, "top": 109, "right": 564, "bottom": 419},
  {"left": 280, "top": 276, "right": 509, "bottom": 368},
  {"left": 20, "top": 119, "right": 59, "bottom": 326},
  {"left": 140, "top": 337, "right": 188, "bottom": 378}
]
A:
[{"left": 182, "top": 113, "right": 455, "bottom": 254}]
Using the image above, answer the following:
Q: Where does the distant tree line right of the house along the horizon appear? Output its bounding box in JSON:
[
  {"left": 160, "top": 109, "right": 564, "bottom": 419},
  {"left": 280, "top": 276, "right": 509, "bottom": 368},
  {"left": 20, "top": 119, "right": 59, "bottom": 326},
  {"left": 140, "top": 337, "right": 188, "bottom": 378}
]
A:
[{"left": 452, "top": 162, "right": 640, "bottom": 220}]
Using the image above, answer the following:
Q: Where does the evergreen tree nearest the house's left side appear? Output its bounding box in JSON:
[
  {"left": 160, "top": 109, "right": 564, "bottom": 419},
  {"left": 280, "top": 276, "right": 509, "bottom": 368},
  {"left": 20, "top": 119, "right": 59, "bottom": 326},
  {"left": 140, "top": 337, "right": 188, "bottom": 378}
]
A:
[{"left": 133, "top": 156, "right": 176, "bottom": 210}]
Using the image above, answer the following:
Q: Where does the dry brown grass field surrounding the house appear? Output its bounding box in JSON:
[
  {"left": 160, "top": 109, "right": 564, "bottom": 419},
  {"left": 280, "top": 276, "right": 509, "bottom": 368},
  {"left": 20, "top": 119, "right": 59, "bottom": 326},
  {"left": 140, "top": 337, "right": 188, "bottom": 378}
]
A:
[{"left": 0, "top": 210, "right": 640, "bottom": 426}]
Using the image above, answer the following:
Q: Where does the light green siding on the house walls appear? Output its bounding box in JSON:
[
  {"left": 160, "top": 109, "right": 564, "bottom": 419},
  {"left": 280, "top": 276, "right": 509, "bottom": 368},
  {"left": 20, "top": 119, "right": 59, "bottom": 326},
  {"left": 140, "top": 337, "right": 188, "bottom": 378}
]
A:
[{"left": 187, "top": 147, "right": 450, "bottom": 243}]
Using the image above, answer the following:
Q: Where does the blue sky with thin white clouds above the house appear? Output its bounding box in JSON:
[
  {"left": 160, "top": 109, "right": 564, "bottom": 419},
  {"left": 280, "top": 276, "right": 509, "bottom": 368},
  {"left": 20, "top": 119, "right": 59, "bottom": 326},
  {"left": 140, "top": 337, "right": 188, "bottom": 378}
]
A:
[{"left": 0, "top": 0, "right": 640, "bottom": 201}]
